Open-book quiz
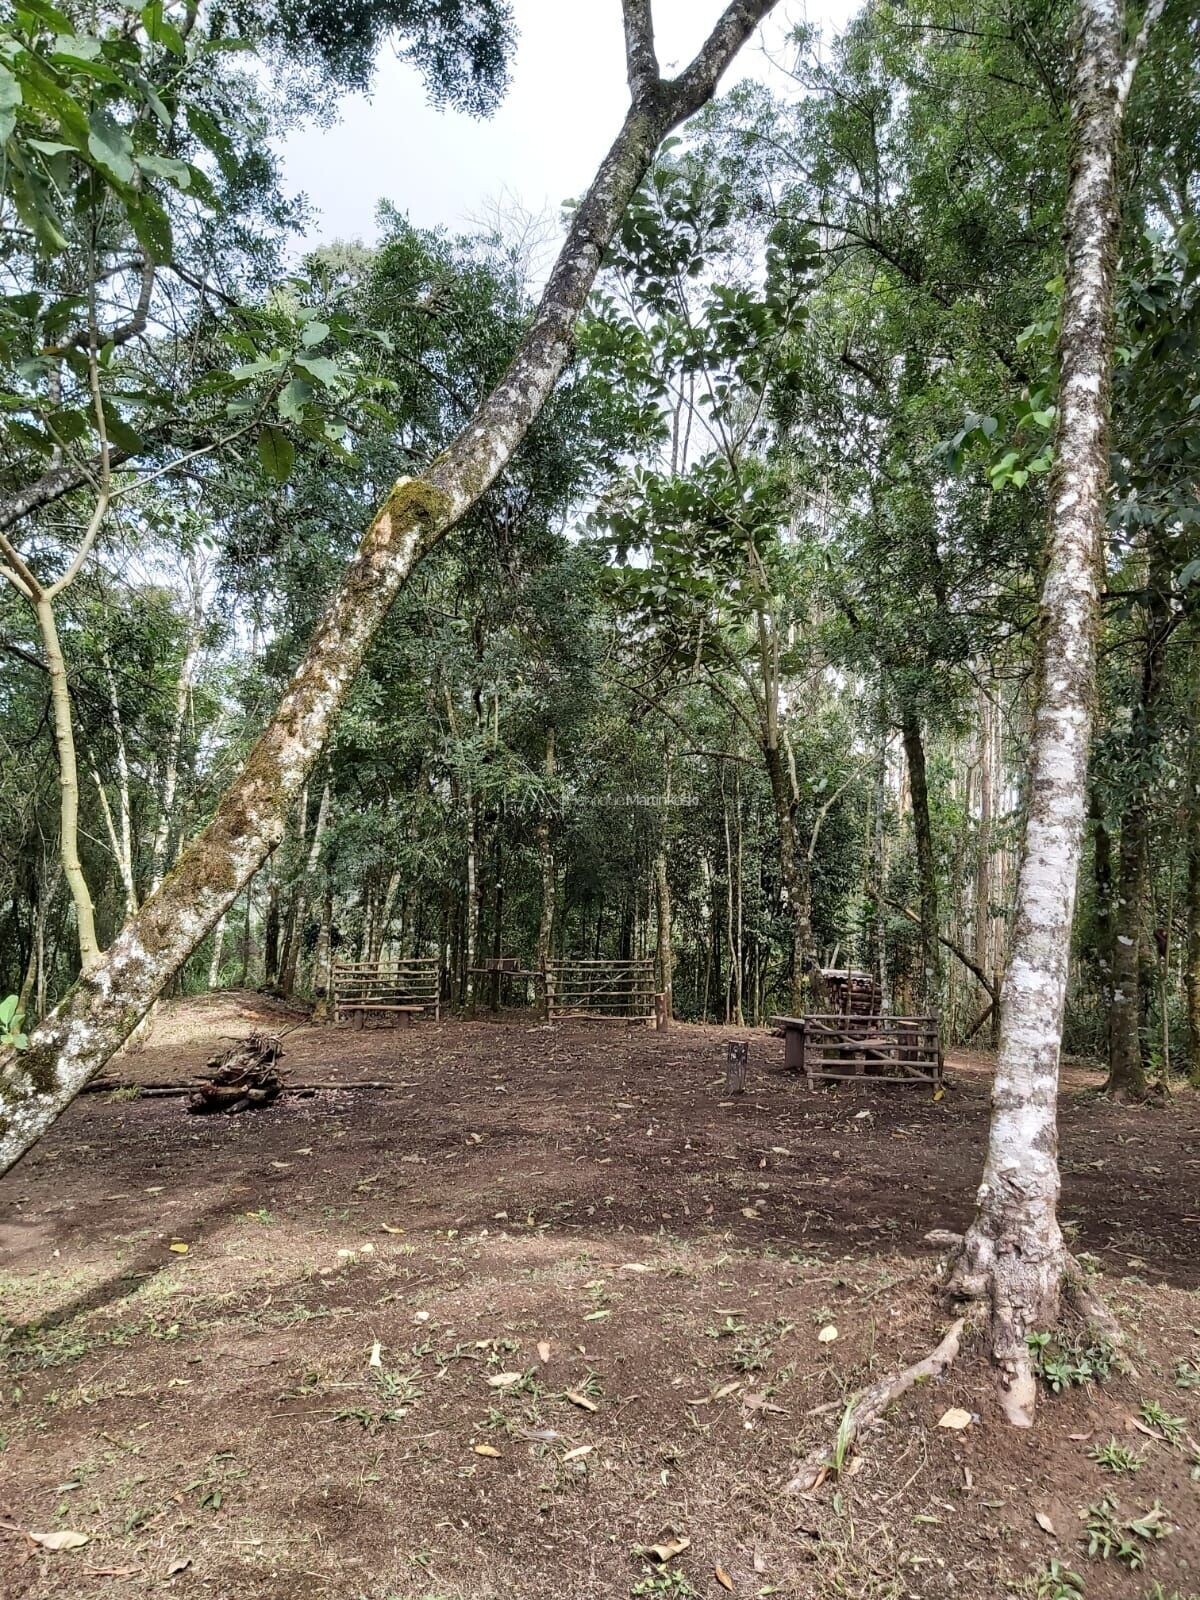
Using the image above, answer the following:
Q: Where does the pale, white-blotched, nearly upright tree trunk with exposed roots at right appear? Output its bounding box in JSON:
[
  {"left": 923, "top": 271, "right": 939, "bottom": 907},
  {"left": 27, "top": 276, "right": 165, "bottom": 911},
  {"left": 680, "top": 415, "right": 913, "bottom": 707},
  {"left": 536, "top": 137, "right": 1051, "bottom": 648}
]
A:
[{"left": 952, "top": 0, "right": 1149, "bottom": 1426}]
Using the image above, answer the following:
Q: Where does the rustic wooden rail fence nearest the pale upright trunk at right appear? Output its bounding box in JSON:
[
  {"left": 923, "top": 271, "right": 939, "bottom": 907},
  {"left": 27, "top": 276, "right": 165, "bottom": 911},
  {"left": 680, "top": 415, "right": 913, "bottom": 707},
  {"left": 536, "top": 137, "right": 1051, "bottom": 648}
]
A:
[{"left": 773, "top": 1013, "right": 941, "bottom": 1088}]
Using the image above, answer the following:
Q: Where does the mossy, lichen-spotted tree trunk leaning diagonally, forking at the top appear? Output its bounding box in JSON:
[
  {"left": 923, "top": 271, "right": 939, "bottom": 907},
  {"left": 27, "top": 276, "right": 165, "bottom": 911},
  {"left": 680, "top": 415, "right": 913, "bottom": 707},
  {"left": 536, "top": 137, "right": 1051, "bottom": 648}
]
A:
[{"left": 0, "top": 0, "right": 774, "bottom": 1174}]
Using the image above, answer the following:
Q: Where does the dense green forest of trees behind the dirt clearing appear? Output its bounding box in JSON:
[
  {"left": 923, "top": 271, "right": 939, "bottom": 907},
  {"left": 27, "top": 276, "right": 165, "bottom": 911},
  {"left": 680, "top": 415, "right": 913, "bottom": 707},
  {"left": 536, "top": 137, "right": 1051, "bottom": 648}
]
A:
[{"left": 0, "top": 0, "right": 1200, "bottom": 1093}]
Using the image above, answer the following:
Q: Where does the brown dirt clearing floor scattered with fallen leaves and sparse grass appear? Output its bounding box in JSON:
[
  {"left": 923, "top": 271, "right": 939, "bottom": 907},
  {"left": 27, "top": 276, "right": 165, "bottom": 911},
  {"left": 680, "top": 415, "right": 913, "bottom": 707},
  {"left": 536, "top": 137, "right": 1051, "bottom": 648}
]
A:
[{"left": 0, "top": 994, "right": 1200, "bottom": 1600}]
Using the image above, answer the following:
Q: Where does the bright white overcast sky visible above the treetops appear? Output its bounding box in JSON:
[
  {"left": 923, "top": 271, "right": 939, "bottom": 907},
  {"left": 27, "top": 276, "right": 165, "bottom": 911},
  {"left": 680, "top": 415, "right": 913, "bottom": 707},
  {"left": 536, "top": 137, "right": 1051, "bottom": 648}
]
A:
[{"left": 282, "top": 0, "right": 859, "bottom": 245}]
